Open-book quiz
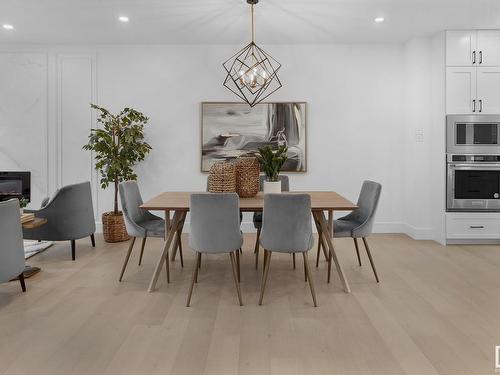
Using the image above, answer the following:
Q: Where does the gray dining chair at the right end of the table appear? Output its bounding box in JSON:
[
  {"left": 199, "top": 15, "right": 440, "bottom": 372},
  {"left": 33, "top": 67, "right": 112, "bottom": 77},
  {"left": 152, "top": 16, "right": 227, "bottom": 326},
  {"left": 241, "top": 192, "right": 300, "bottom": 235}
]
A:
[{"left": 316, "top": 181, "right": 382, "bottom": 283}]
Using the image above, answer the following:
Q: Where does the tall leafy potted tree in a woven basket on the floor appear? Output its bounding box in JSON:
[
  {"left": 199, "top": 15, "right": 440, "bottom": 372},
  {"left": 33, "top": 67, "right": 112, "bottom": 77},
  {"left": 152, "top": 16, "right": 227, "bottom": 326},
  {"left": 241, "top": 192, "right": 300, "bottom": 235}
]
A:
[{"left": 83, "top": 104, "right": 151, "bottom": 242}]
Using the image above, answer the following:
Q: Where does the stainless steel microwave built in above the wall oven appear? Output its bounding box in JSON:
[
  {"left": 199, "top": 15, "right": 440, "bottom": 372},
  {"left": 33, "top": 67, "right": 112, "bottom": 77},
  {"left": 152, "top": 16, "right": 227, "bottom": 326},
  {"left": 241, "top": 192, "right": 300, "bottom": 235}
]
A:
[{"left": 446, "top": 115, "right": 500, "bottom": 154}]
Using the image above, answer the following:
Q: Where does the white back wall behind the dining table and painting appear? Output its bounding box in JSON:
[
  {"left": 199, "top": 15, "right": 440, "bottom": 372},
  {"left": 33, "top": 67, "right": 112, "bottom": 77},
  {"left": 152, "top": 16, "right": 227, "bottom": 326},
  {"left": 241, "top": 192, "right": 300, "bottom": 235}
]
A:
[{"left": 0, "top": 39, "right": 444, "bottom": 238}]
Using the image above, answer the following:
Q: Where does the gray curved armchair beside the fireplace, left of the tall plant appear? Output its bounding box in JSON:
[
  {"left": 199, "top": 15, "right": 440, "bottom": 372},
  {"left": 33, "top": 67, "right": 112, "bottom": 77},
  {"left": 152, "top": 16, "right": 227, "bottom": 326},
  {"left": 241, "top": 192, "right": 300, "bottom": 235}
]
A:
[{"left": 23, "top": 181, "right": 95, "bottom": 260}]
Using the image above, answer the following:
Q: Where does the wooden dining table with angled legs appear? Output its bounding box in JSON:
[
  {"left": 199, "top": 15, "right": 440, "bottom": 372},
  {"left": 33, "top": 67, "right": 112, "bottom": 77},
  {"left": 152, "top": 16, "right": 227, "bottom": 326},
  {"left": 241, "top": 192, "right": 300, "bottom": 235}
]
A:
[{"left": 140, "top": 191, "right": 358, "bottom": 293}]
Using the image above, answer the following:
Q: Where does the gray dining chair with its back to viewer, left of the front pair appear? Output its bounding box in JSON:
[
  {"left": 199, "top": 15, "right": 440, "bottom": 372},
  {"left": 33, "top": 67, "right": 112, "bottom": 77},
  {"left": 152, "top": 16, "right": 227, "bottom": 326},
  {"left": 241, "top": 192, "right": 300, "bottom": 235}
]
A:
[{"left": 186, "top": 193, "right": 243, "bottom": 307}]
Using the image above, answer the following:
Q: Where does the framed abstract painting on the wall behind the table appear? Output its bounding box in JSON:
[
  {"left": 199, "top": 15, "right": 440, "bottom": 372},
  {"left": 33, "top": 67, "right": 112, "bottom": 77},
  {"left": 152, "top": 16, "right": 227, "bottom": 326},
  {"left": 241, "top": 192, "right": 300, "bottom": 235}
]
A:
[{"left": 201, "top": 102, "right": 307, "bottom": 172}]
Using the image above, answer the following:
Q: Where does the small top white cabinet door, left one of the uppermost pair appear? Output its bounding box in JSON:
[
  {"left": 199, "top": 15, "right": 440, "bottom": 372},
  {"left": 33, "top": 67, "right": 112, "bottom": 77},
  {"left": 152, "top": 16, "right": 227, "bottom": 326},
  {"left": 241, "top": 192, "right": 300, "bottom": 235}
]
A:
[{"left": 446, "top": 31, "right": 478, "bottom": 66}]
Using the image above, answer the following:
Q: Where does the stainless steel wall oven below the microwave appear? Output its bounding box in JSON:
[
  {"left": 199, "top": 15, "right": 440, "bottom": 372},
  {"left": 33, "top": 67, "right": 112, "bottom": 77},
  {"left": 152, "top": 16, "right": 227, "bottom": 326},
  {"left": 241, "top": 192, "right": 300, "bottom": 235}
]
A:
[{"left": 446, "top": 154, "right": 500, "bottom": 211}]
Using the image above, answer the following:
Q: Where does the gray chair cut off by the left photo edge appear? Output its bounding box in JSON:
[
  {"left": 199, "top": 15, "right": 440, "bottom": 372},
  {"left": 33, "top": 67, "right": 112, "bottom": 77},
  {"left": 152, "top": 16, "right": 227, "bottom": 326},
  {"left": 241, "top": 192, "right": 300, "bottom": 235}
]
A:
[{"left": 0, "top": 199, "right": 26, "bottom": 292}]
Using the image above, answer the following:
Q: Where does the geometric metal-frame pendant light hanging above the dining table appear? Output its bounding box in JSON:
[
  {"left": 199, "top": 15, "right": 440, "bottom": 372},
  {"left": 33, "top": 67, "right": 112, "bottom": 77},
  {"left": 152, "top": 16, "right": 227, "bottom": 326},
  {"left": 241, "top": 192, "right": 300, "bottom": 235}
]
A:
[{"left": 222, "top": 0, "right": 282, "bottom": 107}]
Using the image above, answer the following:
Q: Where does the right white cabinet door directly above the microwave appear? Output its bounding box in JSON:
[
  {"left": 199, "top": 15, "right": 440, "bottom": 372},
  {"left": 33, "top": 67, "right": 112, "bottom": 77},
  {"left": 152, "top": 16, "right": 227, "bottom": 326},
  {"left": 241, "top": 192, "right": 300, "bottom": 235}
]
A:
[{"left": 477, "top": 67, "right": 500, "bottom": 114}]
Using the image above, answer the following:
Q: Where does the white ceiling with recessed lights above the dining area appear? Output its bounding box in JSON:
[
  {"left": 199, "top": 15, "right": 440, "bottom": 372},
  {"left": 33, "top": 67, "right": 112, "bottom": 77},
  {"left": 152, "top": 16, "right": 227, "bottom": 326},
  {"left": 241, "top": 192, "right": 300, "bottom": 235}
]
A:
[{"left": 0, "top": 0, "right": 500, "bottom": 44}]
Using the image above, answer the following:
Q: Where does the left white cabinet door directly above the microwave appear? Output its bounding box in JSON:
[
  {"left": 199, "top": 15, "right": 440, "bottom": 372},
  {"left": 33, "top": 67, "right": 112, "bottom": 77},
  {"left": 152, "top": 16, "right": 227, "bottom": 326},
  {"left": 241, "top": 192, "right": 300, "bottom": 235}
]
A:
[{"left": 446, "top": 66, "right": 478, "bottom": 115}]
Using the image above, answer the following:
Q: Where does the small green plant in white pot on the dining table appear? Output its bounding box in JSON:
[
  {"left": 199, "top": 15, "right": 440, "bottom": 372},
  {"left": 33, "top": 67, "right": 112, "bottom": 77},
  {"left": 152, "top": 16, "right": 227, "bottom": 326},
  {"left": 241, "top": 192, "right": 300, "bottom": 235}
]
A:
[{"left": 257, "top": 145, "right": 288, "bottom": 194}]
